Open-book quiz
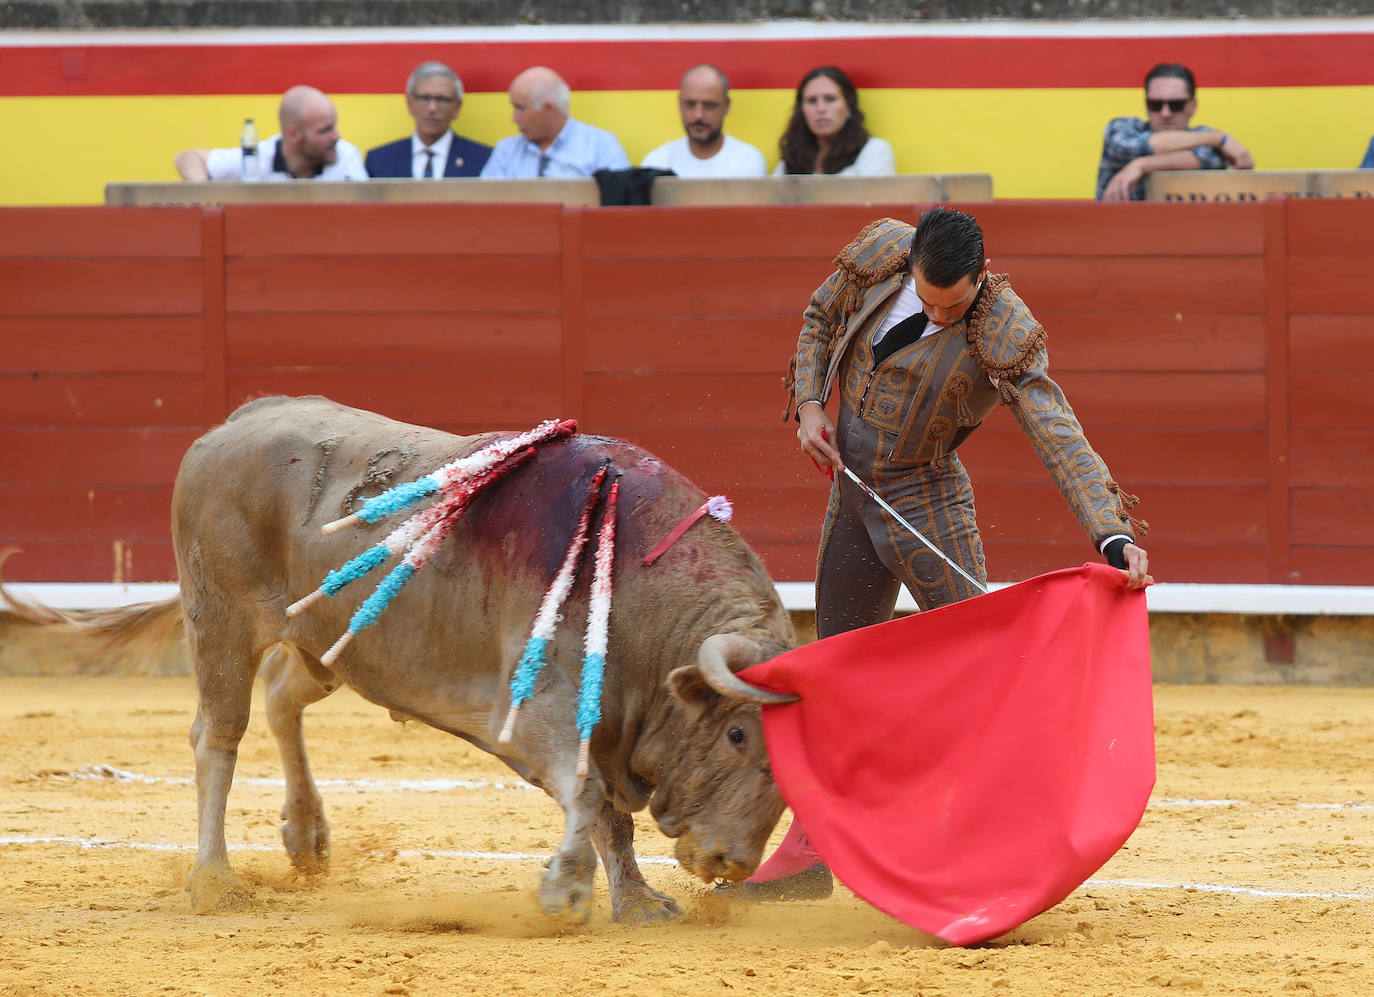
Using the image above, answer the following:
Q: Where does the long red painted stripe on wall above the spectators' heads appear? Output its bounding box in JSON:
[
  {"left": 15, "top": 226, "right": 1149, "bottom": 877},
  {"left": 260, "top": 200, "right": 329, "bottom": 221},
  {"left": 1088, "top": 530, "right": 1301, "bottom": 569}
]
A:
[{"left": 0, "top": 33, "right": 1374, "bottom": 96}]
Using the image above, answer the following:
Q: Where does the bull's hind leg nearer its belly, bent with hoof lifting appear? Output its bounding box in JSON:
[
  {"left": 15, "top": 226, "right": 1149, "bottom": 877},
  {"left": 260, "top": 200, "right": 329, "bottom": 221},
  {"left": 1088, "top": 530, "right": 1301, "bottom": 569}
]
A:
[{"left": 262, "top": 641, "right": 338, "bottom": 873}]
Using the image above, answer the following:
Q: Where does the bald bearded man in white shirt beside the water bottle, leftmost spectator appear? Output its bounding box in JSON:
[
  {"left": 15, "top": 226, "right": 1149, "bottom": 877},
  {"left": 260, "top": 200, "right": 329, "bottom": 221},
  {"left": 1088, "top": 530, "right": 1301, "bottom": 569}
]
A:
[{"left": 174, "top": 87, "right": 367, "bottom": 180}]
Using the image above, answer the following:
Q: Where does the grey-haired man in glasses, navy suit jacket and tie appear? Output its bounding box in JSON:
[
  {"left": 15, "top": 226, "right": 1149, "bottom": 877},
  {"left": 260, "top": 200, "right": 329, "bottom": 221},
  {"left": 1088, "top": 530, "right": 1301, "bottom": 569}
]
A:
[{"left": 365, "top": 62, "right": 492, "bottom": 180}]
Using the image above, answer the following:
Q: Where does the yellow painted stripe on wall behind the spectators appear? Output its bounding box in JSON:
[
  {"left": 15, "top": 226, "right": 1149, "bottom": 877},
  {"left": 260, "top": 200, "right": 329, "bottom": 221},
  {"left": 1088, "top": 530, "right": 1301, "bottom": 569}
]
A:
[{"left": 0, "top": 87, "right": 1374, "bottom": 205}]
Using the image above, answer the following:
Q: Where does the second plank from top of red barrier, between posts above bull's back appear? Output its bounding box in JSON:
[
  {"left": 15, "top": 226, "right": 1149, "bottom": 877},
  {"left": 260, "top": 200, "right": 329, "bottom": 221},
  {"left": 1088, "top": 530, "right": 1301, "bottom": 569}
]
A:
[{"left": 225, "top": 255, "right": 562, "bottom": 313}]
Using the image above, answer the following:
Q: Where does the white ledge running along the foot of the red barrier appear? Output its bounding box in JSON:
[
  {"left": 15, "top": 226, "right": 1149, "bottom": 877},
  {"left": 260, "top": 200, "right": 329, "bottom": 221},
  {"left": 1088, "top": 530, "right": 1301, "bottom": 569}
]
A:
[{"left": 7, "top": 582, "right": 1374, "bottom": 617}]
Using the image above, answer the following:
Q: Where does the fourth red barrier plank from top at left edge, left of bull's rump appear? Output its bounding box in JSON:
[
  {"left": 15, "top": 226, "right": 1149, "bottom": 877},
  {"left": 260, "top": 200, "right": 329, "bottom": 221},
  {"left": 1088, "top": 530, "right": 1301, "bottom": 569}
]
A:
[{"left": 0, "top": 372, "right": 205, "bottom": 426}]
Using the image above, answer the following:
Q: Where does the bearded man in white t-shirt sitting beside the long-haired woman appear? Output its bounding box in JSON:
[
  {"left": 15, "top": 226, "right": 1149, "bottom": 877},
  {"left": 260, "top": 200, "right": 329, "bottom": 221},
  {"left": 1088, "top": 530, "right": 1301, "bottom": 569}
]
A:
[{"left": 642, "top": 63, "right": 768, "bottom": 177}]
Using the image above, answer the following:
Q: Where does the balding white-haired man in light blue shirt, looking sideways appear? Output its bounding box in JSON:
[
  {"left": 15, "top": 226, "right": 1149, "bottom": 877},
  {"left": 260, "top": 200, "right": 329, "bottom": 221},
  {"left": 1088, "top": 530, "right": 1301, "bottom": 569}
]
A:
[{"left": 482, "top": 66, "right": 629, "bottom": 179}]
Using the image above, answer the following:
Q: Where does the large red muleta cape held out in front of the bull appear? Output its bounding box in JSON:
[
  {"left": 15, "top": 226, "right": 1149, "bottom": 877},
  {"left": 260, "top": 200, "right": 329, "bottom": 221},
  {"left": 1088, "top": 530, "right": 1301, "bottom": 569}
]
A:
[{"left": 741, "top": 564, "right": 1154, "bottom": 945}]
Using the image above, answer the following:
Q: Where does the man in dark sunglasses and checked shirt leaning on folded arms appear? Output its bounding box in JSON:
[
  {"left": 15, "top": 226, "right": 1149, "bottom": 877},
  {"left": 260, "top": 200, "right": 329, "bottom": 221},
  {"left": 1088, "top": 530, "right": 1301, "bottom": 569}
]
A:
[{"left": 1098, "top": 62, "right": 1254, "bottom": 200}]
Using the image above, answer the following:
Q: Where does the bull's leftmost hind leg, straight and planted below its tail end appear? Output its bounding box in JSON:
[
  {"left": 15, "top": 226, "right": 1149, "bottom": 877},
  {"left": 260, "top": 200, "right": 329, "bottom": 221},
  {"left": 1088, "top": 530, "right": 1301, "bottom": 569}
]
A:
[{"left": 187, "top": 626, "right": 256, "bottom": 913}]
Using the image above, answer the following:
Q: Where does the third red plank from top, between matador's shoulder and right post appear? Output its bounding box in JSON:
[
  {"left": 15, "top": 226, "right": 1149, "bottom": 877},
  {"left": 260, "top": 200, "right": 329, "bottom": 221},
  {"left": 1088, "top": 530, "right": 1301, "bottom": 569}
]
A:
[{"left": 1032, "top": 313, "right": 1265, "bottom": 371}]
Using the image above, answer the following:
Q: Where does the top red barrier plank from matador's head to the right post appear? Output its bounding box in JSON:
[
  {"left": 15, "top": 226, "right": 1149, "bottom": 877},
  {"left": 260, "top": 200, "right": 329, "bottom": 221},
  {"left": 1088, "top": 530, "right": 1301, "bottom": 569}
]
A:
[{"left": 970, "top": 202, "right": 1264, "bottom": 258}]
